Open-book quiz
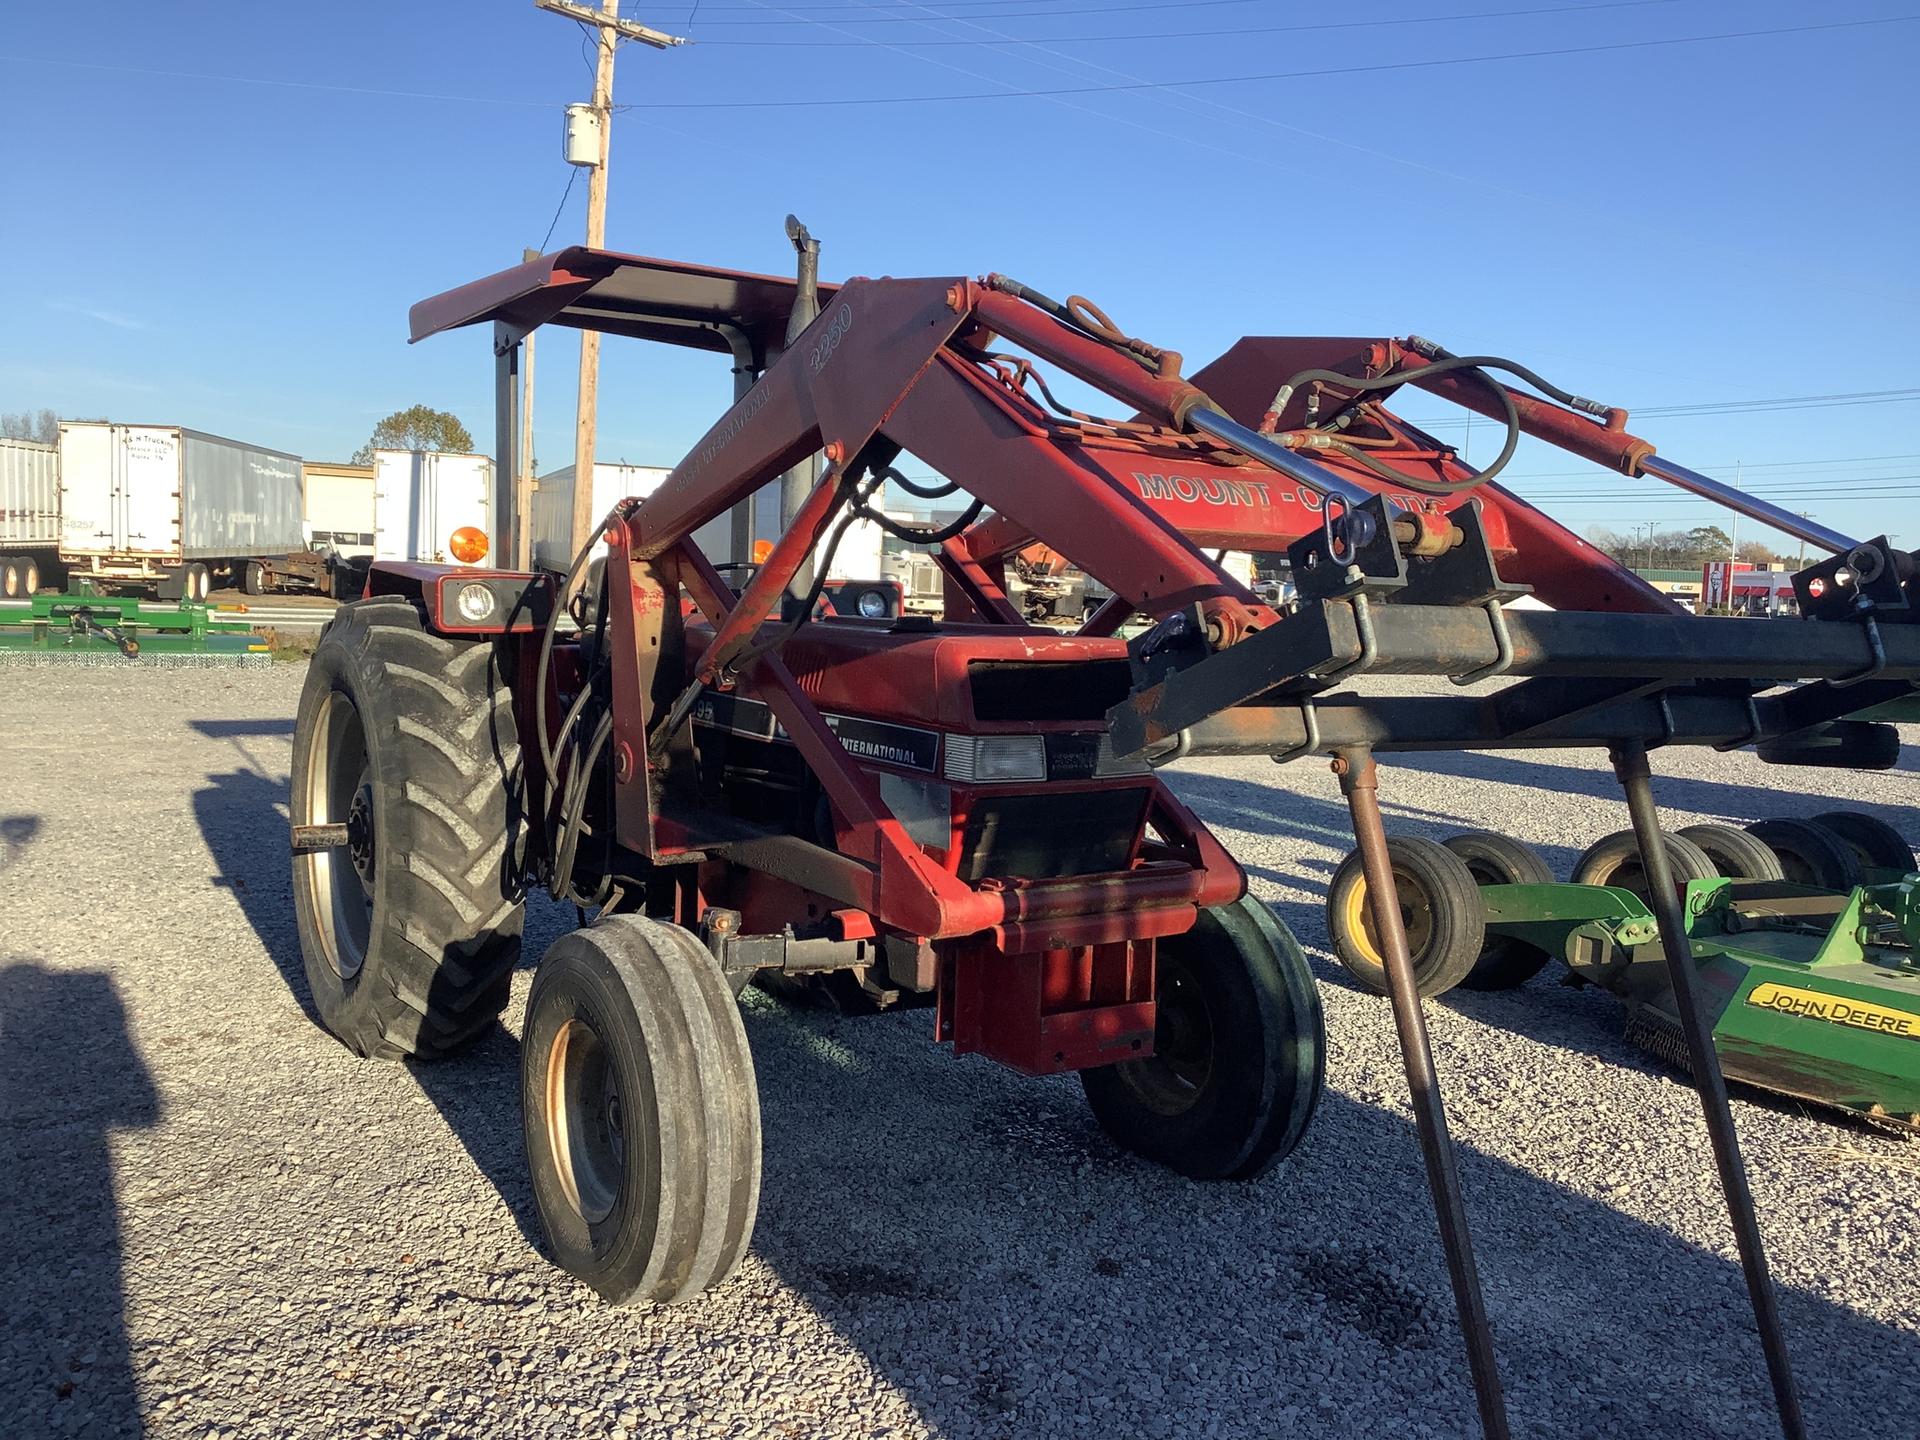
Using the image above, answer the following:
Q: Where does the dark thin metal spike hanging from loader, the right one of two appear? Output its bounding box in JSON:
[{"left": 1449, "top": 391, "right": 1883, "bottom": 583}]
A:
[{"left": 1613, "top": 741, "right": 1807, "bottom": 1440}]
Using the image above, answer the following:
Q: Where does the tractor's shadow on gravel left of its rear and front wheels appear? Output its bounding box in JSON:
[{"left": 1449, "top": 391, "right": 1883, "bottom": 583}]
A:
[{"left": 192, "top": 720, "right": 572, "bottom": 1246}]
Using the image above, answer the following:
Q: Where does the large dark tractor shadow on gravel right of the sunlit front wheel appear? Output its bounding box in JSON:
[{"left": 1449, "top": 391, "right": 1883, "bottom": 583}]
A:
[{"left": 747, "top": 996, "right": 1920, "bottom": 1436}]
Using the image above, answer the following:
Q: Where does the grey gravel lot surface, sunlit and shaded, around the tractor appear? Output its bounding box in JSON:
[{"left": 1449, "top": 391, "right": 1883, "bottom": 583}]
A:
[{"left": 0, "top": 666, "right": 1920, "bottom": 1440}]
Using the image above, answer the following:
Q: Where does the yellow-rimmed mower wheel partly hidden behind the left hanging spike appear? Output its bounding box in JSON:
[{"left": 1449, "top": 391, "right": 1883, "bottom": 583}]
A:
[{"left": 1327, "top": 835, "right": 1486, "bottom": 996}]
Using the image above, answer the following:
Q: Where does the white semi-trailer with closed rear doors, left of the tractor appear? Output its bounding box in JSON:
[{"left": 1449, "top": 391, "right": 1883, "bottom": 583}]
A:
[{"left": 60, "top": 420, "right": 305, "bottom": 599}]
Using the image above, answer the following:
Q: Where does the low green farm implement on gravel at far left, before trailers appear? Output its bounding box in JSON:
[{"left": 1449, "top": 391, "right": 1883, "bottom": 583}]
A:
[{"left": 0, "top": 595, "right": 269, "bottom": 660}]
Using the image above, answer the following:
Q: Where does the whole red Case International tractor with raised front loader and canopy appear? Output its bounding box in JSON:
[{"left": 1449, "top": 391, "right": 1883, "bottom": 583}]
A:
[{"left": 292, "top": 231, "right": 1920, "bottom": 1436}]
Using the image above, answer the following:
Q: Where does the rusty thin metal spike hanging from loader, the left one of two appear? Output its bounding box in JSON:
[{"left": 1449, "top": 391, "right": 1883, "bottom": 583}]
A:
[{"left": 1332, "top": 749, "right": 1509, "bottom": 1440}]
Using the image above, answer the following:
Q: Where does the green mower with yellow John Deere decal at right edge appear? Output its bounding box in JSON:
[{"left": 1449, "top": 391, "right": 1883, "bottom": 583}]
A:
[{"left": 1480, "top": 872, "right": 1920, "bottom": 1129}]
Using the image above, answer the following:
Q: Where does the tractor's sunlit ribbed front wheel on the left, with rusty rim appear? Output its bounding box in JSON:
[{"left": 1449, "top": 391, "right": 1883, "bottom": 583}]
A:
[{"left": 520, "top": 916, "right": 760, "bottom": 1306}]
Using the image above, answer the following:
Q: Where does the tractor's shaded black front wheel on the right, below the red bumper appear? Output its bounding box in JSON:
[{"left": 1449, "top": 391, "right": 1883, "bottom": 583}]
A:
[{"left": 1081, "top": 895, "right": 1327, "bottom": 1181}]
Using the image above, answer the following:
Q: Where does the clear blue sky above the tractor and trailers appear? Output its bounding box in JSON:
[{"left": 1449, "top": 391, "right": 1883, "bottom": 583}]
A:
[{"left": 0, "top": 0, "right": 1920, "bottom": 545}]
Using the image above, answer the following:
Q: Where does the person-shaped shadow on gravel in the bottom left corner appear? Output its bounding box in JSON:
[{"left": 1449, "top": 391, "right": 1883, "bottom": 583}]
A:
[{"left": 0, "top": 952, "right": 161, "bottom": 1436}]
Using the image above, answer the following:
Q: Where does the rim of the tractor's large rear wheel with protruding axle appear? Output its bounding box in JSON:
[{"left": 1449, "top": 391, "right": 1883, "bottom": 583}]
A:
[{"left": 298, "top": 689, "right": 378, "bottom": 981}]
